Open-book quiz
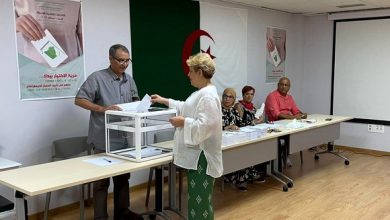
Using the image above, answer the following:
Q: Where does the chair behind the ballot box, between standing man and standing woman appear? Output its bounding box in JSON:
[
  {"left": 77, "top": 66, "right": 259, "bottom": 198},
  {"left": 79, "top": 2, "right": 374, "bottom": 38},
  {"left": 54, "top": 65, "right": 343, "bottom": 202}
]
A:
[{"left": 145, "top": 130, "right": 184, "bottom": 210}]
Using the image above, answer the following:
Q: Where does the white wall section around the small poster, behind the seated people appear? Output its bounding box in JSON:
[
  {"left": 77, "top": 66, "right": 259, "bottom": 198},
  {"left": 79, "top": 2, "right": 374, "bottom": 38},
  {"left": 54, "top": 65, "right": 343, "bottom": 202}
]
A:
[{"left": 205, "top": 0, "right": 304, "bottom": 107}]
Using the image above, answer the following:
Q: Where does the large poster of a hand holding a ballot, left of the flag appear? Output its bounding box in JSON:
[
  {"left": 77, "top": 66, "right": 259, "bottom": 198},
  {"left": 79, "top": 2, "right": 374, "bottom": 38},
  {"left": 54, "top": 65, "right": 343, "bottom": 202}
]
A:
[{"left": 14, "top": 0, "right": 85, "bottom": 100}]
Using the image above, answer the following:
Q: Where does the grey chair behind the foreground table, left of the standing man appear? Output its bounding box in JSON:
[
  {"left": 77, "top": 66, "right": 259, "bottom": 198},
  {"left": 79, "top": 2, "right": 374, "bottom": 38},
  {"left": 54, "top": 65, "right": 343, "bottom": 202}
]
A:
[{"left": 44, "top": 136, "right": 92, "bottom": 220}]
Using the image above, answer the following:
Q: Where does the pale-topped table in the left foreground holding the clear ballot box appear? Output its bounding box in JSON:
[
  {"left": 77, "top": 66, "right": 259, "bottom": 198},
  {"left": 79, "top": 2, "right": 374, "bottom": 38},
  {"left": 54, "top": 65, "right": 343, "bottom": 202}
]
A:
[{"left": 0, "top": 154, "right": 172, "bottom": 220}]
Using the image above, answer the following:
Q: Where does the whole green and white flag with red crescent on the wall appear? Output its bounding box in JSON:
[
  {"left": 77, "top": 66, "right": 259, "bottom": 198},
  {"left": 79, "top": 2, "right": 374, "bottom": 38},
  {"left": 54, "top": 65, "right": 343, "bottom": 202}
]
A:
[{"left": 130, "top": 0, "right": 248, "bottom": 100}]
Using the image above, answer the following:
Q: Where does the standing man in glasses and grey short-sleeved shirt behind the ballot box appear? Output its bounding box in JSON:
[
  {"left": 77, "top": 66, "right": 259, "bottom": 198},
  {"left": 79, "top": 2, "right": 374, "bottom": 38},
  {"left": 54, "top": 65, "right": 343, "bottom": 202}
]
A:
[{"left": 75, "top": 44, "right": 143, "bottom": 220}]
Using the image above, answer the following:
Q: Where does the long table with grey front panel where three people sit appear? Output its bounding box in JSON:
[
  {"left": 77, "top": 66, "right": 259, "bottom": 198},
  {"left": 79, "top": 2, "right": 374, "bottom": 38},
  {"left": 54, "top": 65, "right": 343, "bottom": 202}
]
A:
[{"left": 222, "top": 114, "right": 352, "bottom": 191}]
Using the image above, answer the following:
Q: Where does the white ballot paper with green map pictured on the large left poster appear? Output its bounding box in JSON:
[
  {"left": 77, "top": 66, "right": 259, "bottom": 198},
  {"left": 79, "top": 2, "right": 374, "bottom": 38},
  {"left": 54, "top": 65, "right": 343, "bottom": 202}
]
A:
[{"left": 31, "top": 29, "right": 68, "bottom": 68}]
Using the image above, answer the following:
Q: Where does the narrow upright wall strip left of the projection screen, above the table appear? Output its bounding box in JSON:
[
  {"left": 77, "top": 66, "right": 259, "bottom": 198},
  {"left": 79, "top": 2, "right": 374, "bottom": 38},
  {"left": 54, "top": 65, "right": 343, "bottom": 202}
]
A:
[{"left": 301, "top": 15, "right": 333, "bottom": 114}]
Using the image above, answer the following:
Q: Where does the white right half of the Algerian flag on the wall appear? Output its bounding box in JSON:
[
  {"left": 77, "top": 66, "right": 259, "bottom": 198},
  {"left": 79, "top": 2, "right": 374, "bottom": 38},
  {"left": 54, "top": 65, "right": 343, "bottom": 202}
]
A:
[{"left": 200, "top": 2, "right": 248, "bottom": 96}]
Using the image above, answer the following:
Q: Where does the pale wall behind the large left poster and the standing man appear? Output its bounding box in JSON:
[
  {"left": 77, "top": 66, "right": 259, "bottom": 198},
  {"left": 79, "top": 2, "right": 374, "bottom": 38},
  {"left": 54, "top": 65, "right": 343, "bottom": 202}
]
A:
[{"left": 0, "top": 0, "right": 147, "bottom": 214}]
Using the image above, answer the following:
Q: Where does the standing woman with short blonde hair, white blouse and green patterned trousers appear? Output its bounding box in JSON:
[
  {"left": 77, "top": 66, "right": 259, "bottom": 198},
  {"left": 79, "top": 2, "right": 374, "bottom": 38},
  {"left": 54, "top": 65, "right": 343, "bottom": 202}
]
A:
[{"left": 151, "top": 53, "right": 223, "bottom": 220}]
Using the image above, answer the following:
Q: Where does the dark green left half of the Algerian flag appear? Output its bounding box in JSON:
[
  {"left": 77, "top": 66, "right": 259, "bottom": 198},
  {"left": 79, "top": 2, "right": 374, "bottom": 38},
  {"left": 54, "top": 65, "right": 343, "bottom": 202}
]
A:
[{"left": 131, "top": 0, "right": 200, "bottom": 100}]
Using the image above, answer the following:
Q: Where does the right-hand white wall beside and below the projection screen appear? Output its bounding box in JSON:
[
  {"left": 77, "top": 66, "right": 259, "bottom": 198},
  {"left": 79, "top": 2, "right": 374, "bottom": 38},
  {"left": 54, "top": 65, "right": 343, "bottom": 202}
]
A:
[{"left": 302, "top": 16, "right": 390, "bottom": 152}]
